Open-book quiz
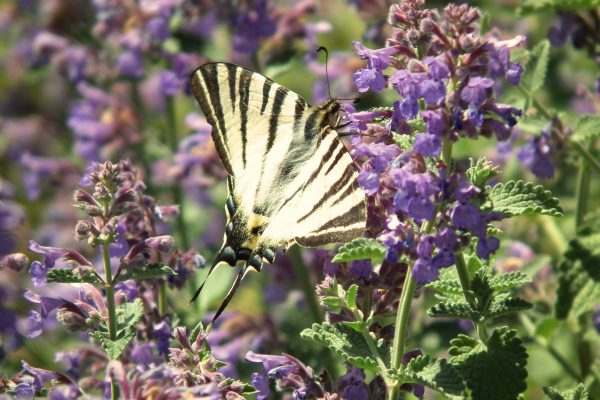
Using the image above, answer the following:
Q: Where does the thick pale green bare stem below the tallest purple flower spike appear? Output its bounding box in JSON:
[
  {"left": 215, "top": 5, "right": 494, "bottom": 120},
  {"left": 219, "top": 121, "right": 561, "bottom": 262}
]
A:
[{"left": 387, "top": 265, "right": 417, "bottom": 400}]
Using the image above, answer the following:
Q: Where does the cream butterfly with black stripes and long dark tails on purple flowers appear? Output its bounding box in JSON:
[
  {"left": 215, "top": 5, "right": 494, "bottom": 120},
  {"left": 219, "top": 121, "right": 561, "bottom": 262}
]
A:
[{"left": 190, "top": 63, "right": 366, "bottom": 325}]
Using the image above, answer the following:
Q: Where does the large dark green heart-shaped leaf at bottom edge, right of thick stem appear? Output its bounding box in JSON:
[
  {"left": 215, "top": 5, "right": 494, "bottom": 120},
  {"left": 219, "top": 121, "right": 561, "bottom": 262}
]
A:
[{"left": 449, "top": 327, "right": 527, "bottom": 400}]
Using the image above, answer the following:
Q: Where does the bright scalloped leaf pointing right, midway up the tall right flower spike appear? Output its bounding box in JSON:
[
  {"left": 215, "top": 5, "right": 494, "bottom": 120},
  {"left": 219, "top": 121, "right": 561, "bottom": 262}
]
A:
[{"left": 486, "top": 181, "right": 563, "bottom": 216}]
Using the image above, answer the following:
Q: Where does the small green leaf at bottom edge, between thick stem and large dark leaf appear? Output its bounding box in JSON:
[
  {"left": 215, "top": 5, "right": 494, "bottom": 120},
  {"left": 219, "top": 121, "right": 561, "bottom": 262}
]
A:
[{"left": 391, "top": 356, "right": 465, "bottom": 395}]
